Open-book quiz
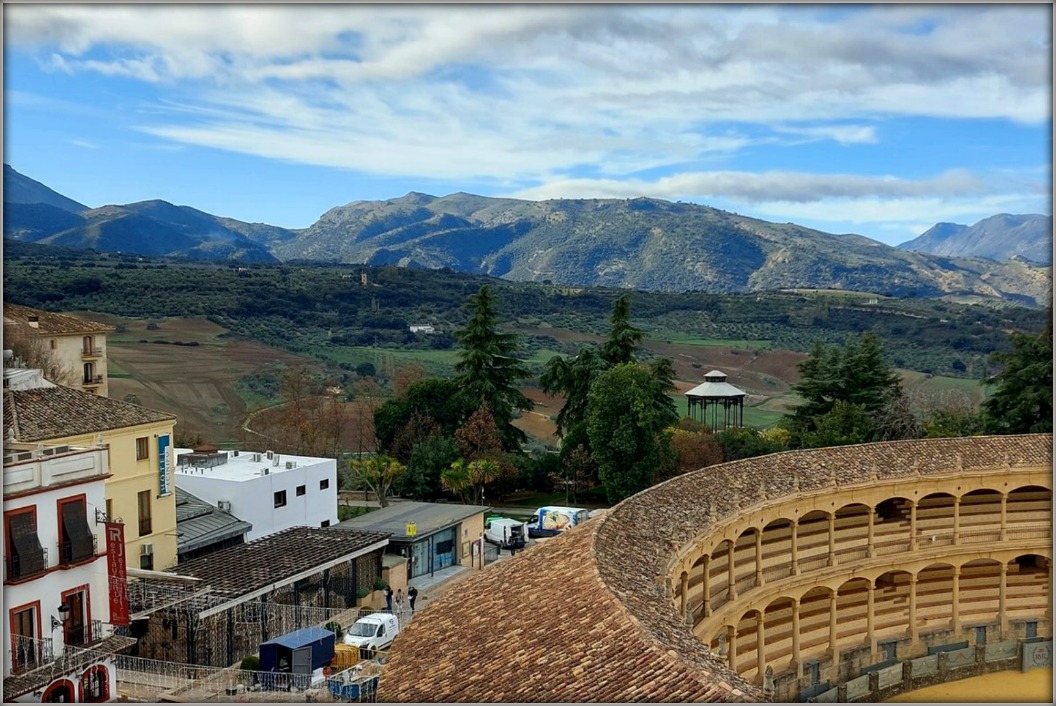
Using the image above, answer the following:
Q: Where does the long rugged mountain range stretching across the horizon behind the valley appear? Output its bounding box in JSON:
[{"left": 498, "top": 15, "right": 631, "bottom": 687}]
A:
[{"left": 4, "top": 165, "right": 1051, "bottom": 305}]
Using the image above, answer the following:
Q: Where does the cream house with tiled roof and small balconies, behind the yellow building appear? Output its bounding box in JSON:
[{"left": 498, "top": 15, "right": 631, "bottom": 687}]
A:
[{"left": 3, "top": 302, "right": 114, "bottom": 397}]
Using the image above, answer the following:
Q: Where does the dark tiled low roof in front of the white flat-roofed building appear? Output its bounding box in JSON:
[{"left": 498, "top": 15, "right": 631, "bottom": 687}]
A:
[{"left": 173, "top": 527, "right": 389, "bottom": 598}]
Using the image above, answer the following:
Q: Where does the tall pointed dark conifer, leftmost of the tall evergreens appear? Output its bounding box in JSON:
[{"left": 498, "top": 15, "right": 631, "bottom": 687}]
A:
[{"left": 455, "top": 285, "right": 532, "bottom": 451}]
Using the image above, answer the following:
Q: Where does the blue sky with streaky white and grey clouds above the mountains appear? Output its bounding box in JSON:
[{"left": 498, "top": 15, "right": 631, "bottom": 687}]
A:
[{"left": 3, "top": 3, "right": 1053, "bottom": 245}]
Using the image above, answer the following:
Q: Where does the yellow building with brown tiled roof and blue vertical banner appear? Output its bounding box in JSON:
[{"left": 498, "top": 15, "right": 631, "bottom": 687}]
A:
[{"left": 3, "top": 386, "right": 176, "bottom": 570}]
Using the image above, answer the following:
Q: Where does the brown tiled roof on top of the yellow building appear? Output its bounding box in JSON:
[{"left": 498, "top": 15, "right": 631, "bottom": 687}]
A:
[{"left": 3, "top": 385, "right": 176, "bottom": 441}]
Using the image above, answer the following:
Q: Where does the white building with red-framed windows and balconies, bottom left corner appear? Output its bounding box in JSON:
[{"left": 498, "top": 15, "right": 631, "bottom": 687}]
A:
[{"left": 3, "top": 441, "right": 135, "bottom": 702}]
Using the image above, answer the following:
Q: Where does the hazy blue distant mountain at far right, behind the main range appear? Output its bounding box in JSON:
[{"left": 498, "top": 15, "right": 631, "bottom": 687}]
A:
[{"left": 898, "top": 213, "right": 1053, "bottom": 265}]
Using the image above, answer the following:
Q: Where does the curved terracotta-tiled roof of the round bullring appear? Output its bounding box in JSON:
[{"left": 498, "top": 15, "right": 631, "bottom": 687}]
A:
[{"left": 378, "top": 434, "right": 1053, "bottom": 703}]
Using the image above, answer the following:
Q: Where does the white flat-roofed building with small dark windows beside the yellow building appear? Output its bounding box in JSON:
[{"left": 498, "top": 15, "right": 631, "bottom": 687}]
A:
[{"left": 175, "top": 449, "right": 338, "bottom": 541}]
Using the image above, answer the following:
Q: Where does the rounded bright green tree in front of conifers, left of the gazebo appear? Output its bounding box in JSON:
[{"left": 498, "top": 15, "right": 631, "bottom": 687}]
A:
[{"left": 587, "top": 363, "right": 678, "bottom": 503}]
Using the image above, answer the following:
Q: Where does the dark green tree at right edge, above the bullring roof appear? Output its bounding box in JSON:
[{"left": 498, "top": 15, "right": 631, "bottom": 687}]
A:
[{"left": 983, "top": 321, "right": 1053, "bottom": 434}]
